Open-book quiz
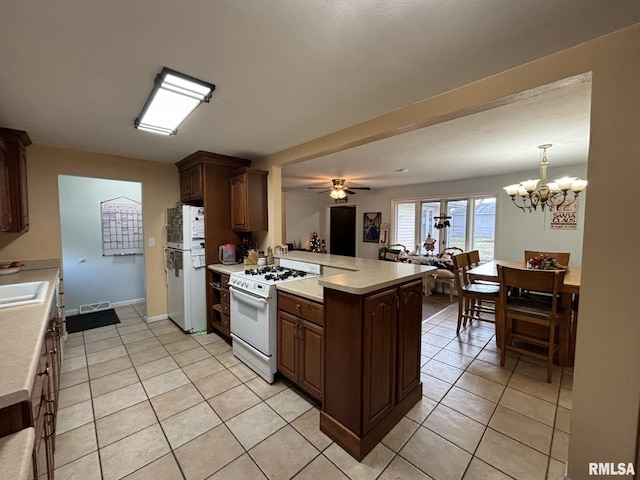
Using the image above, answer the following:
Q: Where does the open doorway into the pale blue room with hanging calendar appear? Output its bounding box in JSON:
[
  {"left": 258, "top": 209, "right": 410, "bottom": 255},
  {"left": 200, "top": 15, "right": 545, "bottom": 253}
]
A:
[{"left": 58, "top": 175, "right": 146, "bottom": 315}]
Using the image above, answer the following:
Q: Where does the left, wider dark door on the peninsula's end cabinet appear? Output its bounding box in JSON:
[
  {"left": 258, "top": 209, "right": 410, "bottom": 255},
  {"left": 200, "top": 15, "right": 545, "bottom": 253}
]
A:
[{"left": 362, "top": 289, "right": 397, "bottom": 433}]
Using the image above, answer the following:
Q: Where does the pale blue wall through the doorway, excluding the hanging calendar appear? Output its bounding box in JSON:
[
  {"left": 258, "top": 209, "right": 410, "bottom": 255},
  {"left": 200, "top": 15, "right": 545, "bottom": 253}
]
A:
[{"left": 58, "top": 175, "right": 146, "bottom": 313}]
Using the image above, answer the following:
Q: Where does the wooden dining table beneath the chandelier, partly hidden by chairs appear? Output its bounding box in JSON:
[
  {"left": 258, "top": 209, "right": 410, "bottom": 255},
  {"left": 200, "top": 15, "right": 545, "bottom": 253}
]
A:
[{"left": 467, "top": 260, "right": 581, "bottom": 367}]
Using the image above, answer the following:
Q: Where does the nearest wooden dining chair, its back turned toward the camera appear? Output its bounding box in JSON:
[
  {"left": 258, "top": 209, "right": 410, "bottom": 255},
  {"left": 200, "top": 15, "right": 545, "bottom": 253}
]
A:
[{"left": 498, "top": 265, "right": 569, "bottom": 382}]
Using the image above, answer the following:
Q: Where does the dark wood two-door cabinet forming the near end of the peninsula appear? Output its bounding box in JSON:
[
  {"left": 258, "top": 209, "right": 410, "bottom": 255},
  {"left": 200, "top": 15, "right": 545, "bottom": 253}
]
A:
[{"left": 320, "top": 279, "right": 422, "bottom": 461}]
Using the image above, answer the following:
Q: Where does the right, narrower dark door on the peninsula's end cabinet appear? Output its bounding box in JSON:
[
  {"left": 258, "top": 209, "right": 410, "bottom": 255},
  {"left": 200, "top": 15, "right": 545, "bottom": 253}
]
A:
[{"left": 397, "top": 281, "right": 422, "bottom": 402}]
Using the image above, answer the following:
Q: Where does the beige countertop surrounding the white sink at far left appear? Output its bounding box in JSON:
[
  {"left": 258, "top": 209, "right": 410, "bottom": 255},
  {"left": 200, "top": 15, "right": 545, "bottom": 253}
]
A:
[{"left": 0, "top": 268, "right": 60, "bottom": 408}]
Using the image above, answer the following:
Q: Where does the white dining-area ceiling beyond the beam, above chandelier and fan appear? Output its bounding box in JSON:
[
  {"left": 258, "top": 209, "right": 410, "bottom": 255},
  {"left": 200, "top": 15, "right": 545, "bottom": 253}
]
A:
[{"left": 282, "top": 76, "right": 591, "bottom": 191}]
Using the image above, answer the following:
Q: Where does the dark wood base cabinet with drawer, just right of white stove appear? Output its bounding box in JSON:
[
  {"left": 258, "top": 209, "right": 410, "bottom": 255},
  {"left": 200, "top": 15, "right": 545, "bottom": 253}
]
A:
[{"left": 278, "top": 292, "right": 324, "bottom": 402}]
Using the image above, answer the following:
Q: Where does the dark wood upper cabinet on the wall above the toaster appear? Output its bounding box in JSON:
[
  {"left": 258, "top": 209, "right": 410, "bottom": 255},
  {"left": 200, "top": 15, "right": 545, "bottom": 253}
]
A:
[{"left": 230, "top": 168, "right": 269, "bottom": 232}]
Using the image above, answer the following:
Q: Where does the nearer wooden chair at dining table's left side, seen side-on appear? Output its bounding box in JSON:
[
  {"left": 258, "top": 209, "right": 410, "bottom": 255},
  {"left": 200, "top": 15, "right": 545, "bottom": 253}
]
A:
[{"left": 453, "top": 253, "right": 500, "bottom": 336}]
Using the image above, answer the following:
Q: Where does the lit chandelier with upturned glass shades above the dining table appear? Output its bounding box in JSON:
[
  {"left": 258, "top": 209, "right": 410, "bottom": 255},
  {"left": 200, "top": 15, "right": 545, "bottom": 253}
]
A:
[{"left": 504, "top": 143, "right": 587, "bottom": 212}]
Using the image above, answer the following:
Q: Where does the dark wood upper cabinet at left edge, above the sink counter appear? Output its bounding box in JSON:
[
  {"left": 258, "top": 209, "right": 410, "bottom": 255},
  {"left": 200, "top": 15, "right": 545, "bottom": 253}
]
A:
[{"left": 0, "top": 128, "right": 31, "bottom": 233}]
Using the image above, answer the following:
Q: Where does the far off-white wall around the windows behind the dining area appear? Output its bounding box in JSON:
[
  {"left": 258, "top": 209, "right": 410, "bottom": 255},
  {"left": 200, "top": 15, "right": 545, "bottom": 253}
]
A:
[{"left": 285, "top": 163, "right": 589, "bottom": 265}]
